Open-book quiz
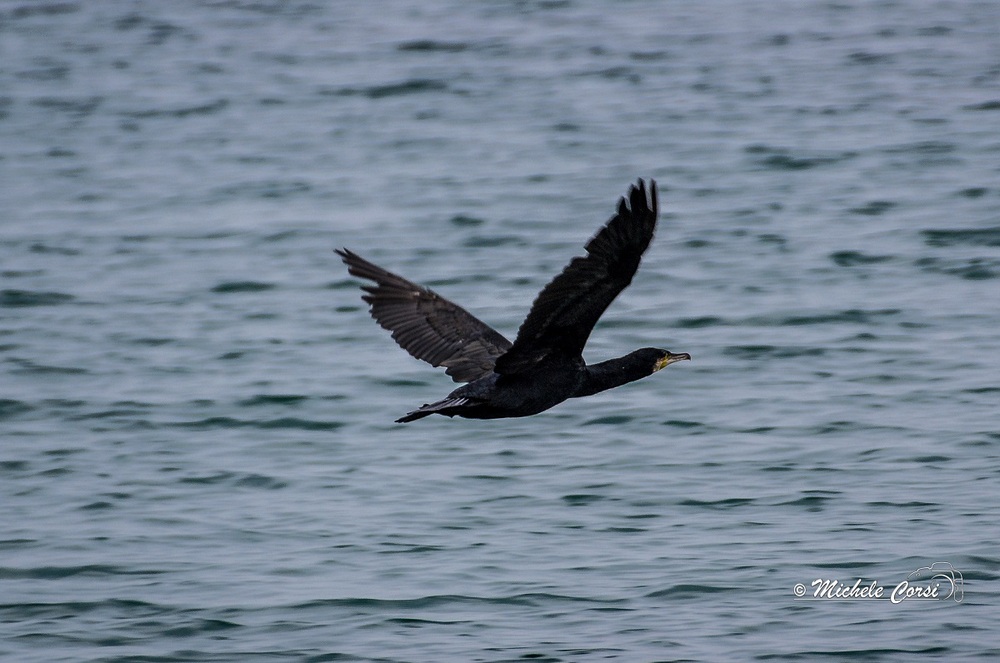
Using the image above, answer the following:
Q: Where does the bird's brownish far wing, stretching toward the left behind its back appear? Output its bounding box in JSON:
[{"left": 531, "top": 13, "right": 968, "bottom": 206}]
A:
[{"left": 336, "top": 249, "right": 511, "bottom": 382}]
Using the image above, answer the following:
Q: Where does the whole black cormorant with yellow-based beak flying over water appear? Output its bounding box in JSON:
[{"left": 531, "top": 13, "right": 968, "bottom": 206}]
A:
[{"left": 336, "top": 180, "right": 691, "bottom": 423}]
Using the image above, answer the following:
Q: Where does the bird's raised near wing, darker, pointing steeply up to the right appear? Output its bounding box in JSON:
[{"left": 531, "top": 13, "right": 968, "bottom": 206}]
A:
[{"left": 494, "top": 180, "right": 659, "bottom": 374}]
